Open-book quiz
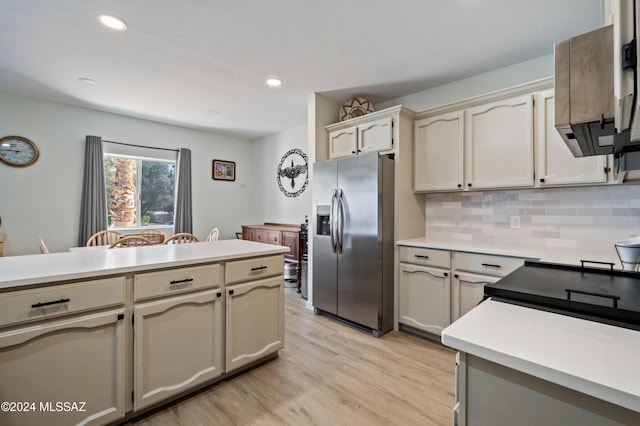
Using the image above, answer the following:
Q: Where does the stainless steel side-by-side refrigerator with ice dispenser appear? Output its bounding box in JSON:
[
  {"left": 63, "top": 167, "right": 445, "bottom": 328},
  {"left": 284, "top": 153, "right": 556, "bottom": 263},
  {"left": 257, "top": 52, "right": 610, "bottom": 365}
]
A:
[{"left": 313, "top": 153, "right": 394, "bottom": 337}]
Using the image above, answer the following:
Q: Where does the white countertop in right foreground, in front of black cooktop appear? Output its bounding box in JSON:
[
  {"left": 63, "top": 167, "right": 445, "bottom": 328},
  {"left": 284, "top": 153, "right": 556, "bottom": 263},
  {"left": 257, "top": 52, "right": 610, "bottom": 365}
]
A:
[{"left": 442, "top": 300, "right": 640, "bottom": 412}]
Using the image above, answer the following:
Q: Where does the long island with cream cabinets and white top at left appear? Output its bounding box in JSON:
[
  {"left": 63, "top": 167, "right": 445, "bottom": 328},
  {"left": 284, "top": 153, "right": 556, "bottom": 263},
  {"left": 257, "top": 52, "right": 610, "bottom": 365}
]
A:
[{"left": 0, "top": 240, "right": 289, "bottom": 425}]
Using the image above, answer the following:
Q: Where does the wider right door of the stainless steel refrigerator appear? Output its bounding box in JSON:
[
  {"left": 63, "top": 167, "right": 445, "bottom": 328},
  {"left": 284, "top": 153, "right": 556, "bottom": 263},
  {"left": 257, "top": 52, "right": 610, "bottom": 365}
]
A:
[{"left": 338, "top": 153, "right": 382, "bottom": 330}]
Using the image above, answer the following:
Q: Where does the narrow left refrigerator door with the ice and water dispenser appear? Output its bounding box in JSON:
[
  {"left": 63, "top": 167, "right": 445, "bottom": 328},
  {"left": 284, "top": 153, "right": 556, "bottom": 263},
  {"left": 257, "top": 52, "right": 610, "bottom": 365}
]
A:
[{"left": 312, "top": 160, "right": 338, "bottom": 314}]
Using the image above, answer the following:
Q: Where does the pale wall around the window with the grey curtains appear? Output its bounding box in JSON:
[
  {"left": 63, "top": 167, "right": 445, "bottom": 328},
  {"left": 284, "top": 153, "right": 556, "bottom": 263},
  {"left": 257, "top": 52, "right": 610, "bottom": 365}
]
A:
[{"left": 0, "top": 93, "right": 255, "bottom": 256}]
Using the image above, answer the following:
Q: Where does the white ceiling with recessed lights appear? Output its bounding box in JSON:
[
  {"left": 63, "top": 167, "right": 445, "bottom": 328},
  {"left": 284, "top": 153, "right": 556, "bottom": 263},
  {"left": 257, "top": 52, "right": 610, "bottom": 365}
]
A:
[{"left": 0, "top": 0, "right": 601, "bottom": 138}]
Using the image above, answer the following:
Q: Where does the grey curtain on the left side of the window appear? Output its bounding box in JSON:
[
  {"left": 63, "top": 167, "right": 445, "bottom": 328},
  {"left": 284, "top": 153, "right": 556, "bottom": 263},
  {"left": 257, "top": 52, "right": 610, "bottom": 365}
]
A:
[{"left": 78, "top": 136, "right": 107, "bottom": 246}]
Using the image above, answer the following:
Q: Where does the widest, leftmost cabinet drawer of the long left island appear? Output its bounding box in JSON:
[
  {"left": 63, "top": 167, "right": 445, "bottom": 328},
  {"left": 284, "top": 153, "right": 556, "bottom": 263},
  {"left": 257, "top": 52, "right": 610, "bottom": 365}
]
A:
[{"left": 0, "top": 277, "right": 125, "bottom": 327}]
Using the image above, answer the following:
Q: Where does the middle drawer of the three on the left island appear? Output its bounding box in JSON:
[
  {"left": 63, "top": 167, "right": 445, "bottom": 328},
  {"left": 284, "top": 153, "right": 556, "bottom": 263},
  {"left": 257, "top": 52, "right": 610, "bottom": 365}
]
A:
[{"left": 133, "top": 264, "right": 222, "bottom": 300}]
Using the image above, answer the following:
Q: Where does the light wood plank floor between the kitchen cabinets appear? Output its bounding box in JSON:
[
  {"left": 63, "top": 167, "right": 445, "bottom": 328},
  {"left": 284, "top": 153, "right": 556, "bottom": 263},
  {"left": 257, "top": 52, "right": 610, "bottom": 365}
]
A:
[{"left": 132, "top": 288, "right": 455, "bottom": 426}]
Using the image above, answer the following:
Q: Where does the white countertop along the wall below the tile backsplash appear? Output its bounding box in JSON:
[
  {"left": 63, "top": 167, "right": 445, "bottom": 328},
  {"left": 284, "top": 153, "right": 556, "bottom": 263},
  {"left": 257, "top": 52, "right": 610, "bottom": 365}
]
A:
[{"left": 396, "top": 237, "right": 622, "bottom": 269}]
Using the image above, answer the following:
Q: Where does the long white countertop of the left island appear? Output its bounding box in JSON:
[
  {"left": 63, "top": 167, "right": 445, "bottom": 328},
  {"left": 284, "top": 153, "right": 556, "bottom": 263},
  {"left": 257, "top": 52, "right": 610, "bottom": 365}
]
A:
[{"left": 0, "top": 240, "right": 289, "bottom": 292}]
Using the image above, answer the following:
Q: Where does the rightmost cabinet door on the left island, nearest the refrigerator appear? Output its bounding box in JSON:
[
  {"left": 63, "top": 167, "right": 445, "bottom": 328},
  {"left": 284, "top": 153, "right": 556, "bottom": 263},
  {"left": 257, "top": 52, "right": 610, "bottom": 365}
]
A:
[{"left": 226, "top": 276, "right": 284, "bottom": 372}]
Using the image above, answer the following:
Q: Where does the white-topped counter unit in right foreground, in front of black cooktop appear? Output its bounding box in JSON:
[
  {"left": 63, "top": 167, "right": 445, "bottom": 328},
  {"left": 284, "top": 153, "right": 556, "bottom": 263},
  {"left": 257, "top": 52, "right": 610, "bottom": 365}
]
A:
[{"left": 442, "top": 300, "right": 640, "bottom": 426}]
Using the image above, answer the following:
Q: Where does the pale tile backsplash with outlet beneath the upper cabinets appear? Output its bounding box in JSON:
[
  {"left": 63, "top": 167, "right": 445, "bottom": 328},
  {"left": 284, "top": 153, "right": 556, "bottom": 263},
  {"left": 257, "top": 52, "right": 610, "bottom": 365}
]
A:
[{"left": 425, "top": 185, "right": 640, "bottom": 250}]
